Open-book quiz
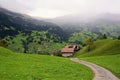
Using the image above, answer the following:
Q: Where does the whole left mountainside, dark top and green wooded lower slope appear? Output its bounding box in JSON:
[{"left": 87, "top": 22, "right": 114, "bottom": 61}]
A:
[{"left": 0, "top": 8, "right": 67, "bottom": 54}]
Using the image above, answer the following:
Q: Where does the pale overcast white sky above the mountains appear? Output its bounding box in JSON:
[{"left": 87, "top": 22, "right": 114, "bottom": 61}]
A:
[{"left": 0, "top": 0, "right": 120, "bottom": 18}]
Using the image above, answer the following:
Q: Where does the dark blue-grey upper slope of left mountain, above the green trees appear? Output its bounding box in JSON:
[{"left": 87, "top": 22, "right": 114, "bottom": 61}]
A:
[{"left": 0, "top": 8, "right": 66, "bottom": 40}]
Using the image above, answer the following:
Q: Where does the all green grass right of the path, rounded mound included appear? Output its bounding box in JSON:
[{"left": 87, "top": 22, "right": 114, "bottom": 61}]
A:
[{"left": 75, "top": 39, "right": 120, "bottom": 78}]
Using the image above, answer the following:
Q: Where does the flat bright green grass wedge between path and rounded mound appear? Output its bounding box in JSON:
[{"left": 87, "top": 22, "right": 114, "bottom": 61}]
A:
[{"left": 80, "top": 54, "right": 120, "bottom": 78}]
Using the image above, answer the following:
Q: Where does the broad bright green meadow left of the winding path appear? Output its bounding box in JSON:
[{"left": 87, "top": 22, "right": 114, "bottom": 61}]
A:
[{"left": 0, "top": 47, "right": 93, "bottom": 80}]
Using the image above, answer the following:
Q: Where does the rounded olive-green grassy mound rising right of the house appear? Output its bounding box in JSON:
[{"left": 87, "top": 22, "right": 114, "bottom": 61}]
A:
[{"left": 74, "top": 39, "right": 120, "bottom": 57}]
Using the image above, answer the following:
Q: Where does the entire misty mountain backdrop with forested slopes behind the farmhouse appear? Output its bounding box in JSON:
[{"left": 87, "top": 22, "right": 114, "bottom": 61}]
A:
[{"left": 0, "top": 8, "right": 120, "bottom": 54}]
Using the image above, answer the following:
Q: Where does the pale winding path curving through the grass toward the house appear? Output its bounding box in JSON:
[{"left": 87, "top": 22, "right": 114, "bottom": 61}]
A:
[{"left": 70, "top": 58, "right": 120, "bottom": 80}]
